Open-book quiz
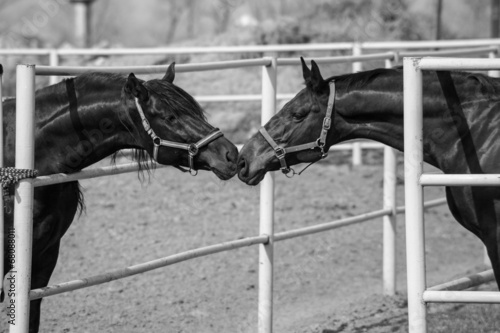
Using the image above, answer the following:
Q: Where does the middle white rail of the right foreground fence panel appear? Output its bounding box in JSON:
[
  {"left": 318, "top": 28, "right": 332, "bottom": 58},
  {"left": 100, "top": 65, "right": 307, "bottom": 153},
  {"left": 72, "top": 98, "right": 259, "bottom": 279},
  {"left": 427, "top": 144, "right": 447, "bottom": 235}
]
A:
[{"left": 420, "top": 173, "right": 500, "bottom": 186}]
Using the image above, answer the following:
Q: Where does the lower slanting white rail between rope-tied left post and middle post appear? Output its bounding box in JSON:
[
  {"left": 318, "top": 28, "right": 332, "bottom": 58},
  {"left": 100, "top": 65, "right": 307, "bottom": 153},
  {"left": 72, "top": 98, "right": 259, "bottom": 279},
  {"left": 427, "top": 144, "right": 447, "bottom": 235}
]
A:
[{"left": 30, "top": 235, "right": 269, "bottom": 300}]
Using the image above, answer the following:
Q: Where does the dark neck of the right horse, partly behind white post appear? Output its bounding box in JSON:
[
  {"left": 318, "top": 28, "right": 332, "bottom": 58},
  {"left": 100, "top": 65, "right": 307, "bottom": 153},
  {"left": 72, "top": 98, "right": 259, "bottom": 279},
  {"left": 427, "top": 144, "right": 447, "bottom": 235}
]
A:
[{"left": 335, "top": 70, "right": 451, "bottom": 168}]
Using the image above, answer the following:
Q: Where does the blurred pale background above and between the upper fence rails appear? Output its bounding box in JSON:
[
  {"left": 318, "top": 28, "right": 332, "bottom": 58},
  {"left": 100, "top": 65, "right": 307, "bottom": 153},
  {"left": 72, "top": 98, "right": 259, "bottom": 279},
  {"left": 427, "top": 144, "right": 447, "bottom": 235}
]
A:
[{"left": 0, "top": 0, "right": 500, "bottom": 143}]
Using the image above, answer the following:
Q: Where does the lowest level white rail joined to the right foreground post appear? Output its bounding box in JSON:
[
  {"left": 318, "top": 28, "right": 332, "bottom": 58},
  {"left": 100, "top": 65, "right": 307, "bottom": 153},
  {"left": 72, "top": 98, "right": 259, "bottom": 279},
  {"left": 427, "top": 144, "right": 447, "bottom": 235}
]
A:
[{"left": 422, "top": 290, "right": 500, "bottom": 303}]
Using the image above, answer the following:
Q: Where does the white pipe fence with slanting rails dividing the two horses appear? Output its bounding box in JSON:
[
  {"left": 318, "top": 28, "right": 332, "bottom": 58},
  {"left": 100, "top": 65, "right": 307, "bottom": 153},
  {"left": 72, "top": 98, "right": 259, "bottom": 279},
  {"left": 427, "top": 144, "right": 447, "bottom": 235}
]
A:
[{"left": 0, "top": 39, "right": 496, "bottom": 333}]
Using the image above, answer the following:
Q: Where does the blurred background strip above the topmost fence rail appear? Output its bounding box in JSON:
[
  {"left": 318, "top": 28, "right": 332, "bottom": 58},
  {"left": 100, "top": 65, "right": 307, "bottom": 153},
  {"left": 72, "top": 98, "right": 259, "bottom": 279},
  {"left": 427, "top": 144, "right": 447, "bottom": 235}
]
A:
[{"left": 0, "top": 0, "right": 498, "bottom": 48}]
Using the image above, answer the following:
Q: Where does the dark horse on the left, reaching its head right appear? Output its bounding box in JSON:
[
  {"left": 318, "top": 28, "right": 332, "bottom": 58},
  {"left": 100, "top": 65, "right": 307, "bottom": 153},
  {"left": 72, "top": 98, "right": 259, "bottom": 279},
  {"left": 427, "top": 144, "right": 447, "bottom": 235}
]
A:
[{"left": 4, "top": 64, "right": 238, "bottom": 332}]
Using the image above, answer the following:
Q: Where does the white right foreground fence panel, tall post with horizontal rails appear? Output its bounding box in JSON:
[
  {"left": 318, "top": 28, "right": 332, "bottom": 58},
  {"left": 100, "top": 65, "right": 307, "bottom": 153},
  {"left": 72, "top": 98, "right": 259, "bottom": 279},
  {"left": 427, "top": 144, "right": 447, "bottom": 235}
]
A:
[{"left": 403, "top": 57, "right": 500, "bottom": 333}]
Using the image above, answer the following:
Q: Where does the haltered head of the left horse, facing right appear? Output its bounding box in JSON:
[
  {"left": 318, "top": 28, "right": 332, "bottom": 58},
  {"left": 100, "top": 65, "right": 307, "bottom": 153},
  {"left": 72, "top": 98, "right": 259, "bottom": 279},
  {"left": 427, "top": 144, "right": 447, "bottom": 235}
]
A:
[{"left": 122, "top": 63, "right": 238, "bottom": 180}]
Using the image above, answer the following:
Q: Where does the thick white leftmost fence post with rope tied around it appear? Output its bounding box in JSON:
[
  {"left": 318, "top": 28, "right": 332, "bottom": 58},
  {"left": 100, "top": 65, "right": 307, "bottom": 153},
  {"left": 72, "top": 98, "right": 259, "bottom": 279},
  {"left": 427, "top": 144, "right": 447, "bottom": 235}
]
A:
[{"left": 9, "top": 65, "right": 35, "bottom": 333}]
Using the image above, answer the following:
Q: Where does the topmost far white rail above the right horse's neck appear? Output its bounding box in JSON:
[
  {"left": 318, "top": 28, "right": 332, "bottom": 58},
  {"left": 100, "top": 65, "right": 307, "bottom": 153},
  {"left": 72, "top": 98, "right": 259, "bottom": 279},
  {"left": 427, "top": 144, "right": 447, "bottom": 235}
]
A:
[{"left": 360, "top": 38, "right": 500, "bottom": 50}]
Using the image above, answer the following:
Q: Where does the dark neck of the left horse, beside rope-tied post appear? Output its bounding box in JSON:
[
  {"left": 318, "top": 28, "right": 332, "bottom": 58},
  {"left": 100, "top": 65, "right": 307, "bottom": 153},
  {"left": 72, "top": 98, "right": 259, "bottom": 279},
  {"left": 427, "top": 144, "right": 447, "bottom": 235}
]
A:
[{"left": 35, "top": 79, "right": 141, "bottom": 173}]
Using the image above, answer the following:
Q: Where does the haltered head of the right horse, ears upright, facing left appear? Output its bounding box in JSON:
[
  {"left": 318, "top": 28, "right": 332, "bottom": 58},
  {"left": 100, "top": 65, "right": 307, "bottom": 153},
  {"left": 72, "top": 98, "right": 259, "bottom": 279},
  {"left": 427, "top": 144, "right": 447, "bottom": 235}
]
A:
[{"left": 238, "top": 58, "right": 333, "bottom": 185}]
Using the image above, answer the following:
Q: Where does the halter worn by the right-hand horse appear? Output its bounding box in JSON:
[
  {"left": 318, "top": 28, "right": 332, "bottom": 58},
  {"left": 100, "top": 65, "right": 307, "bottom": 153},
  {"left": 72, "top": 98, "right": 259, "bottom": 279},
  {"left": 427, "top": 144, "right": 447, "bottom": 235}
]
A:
[{"left": 259, "top": 81, "right": 335, "bottom": 178}]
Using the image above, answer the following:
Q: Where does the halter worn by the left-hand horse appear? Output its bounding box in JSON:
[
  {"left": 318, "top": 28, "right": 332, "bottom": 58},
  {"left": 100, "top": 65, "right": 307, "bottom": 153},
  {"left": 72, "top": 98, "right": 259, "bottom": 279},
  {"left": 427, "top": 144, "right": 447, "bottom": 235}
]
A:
[{"left": 135, "top": 97, "right": 224, "bottom": 176}]
